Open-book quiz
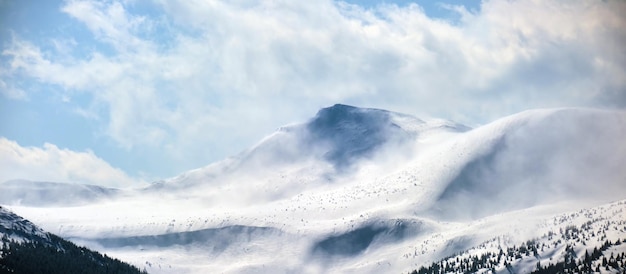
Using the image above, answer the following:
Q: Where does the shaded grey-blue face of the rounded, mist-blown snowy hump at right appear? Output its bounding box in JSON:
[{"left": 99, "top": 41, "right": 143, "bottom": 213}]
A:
[{"left": 426, "top": 109, "right": 626, "bottom": 218}]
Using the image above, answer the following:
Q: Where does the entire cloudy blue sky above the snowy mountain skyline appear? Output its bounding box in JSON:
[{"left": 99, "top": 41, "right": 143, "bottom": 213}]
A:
[{"left": 0, "top": 0, "right": 626, "bottom": 186}]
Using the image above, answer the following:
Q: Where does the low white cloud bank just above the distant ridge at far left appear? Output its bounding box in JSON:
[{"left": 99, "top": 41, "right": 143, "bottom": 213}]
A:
[{"left": 0, "top": 138, "right": 145, "bottom": 188}]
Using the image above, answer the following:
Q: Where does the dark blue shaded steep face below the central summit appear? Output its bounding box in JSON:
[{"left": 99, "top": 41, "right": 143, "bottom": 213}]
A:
[{"left": 303, "top": 104, "right": 411, "bottom": 169}]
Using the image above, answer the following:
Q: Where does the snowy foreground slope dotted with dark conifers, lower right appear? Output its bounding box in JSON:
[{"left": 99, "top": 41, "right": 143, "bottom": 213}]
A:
[{"left": 406, "top": 201, "right": 626, "bottom": 273}]
